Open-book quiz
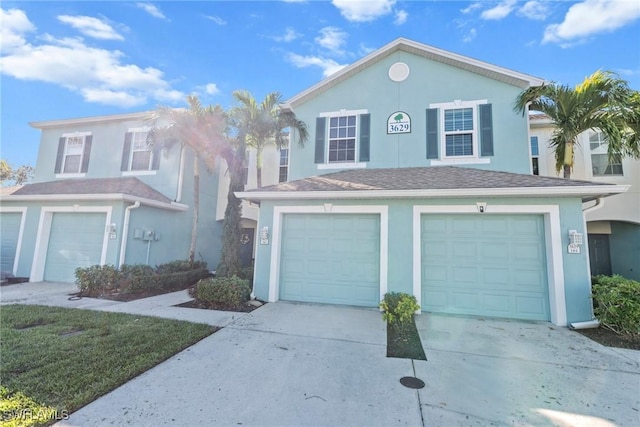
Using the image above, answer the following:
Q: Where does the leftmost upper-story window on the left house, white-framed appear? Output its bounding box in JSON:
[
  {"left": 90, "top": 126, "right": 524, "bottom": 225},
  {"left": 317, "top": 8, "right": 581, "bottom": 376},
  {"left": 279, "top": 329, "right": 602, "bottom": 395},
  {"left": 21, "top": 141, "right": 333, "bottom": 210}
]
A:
[{"left": 54, "top": 132, "right": 92, "bottom": 177}]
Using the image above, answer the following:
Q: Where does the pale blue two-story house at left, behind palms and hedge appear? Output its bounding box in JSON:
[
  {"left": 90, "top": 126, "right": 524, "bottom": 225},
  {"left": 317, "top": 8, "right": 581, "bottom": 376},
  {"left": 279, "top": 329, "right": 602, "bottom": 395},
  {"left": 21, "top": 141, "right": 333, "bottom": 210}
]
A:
[{"left": 0, "top": 112, "right": 286, "bottom": 282}]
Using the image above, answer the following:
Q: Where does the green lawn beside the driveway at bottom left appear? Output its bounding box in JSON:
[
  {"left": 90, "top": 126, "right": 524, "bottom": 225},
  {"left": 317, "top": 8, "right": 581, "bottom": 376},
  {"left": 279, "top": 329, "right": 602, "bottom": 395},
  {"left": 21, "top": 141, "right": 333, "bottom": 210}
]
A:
[{"left": 0, "top": 305, "right": 216, "bottom": 425}]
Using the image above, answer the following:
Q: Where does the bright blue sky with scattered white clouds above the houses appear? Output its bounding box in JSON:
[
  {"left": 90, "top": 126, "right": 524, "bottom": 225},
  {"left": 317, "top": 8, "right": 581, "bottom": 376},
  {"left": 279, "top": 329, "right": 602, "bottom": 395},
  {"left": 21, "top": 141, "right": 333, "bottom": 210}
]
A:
[{"left": 0, "top": 0, "right": 640, "bottom": 167}]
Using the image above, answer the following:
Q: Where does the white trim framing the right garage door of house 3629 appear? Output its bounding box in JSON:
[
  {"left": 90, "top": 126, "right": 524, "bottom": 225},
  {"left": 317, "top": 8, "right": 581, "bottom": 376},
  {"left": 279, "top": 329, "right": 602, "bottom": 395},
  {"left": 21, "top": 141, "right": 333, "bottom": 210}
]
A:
[{"left": 413, "top": 204, "right": 567, "bottom": 326}]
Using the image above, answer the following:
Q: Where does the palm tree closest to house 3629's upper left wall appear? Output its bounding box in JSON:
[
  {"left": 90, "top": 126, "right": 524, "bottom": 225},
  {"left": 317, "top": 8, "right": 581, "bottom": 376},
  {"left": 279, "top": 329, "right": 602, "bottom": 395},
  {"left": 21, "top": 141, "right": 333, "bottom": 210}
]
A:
[{"left": 230, "top": 90, "right": 309, "bottom": 187}]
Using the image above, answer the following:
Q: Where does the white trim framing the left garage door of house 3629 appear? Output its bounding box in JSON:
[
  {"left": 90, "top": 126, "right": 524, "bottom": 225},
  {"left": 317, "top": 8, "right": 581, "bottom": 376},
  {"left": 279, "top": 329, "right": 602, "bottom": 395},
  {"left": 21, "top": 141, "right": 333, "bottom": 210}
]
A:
[{"left": 268, "top": 203, "right": 389, "bottom": 302}]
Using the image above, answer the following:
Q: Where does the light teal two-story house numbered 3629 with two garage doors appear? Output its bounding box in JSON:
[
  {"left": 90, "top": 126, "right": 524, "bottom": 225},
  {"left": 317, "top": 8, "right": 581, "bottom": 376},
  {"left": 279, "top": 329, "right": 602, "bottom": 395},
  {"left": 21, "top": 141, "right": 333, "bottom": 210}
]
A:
[{"left": 239, "top": 39, "right": 627, "bottom": 325}]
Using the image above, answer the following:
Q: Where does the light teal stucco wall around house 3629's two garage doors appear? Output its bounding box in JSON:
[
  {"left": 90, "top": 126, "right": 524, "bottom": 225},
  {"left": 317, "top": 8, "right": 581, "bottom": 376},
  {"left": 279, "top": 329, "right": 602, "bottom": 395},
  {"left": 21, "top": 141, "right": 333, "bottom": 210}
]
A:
[{"left": 254, "top": 197, "right": 592, "bottom": 322}]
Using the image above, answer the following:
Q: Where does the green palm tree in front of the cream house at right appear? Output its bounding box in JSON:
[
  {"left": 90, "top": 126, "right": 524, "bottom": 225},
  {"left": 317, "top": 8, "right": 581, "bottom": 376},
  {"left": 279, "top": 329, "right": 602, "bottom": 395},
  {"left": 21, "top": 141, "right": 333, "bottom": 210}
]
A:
[{"left": 514, "top": 71, "right": 640, "bottom": 178}]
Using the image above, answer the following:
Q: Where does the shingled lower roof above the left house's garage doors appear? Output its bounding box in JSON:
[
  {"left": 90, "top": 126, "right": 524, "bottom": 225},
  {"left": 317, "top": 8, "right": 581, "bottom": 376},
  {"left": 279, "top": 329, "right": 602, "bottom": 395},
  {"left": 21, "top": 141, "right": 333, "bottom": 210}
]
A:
[{"left": 3, "top": 177, "right": 187, "bottom": 210}]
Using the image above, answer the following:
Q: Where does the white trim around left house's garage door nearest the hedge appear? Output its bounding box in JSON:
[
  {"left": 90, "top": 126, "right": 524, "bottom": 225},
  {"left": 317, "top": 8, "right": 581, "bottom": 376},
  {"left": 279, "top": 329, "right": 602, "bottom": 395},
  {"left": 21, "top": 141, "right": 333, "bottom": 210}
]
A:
[{"left": 31, "top": 205, "right": 112, "bottom": 282}]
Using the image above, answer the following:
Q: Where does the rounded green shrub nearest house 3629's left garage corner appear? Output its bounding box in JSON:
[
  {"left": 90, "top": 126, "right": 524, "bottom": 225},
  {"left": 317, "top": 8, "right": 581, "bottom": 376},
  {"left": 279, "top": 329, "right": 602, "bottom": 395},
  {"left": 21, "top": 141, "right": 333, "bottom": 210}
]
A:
[{"left": 193, "top": 275, "right": 251, "bottom": 309}]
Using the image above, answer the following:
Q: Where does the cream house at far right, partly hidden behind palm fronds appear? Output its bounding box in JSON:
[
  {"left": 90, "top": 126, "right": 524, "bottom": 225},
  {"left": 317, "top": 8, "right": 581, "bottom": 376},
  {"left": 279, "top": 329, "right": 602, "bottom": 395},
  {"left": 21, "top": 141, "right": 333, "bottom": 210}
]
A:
[{"left": 530, "top": 114, "right": 640, "bottom": 280}]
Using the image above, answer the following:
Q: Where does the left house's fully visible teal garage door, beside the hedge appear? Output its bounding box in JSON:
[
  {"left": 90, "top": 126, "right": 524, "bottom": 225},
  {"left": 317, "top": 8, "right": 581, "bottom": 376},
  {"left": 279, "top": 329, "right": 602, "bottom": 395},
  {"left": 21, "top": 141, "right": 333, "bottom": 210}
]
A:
[{"left": 44, "top": 212, "right": 106, "bottom": 282}]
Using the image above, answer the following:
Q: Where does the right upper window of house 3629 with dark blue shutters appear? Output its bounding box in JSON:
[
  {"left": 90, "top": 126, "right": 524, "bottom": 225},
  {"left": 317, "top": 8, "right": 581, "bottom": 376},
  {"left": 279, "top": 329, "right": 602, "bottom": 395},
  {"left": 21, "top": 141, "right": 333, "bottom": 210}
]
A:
[{"left": 427, "top": 100, "right": 493, "bottom": 165}]
